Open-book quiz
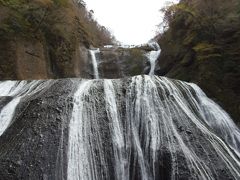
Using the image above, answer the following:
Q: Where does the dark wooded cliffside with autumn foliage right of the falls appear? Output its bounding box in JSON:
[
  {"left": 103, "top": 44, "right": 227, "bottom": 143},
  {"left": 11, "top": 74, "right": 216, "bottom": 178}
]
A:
[{"left": 156, "top": 0, "right": 240, "bottom": 123}]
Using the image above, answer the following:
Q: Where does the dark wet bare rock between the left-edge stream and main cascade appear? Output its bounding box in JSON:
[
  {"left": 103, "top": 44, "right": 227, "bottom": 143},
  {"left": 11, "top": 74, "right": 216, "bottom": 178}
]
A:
[{"left": 0, "top": 80, "right": 73, "bottom": 180}]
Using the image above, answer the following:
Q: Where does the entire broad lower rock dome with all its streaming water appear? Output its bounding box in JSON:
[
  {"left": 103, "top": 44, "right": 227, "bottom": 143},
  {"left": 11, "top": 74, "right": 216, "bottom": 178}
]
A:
[{"left": 0, "top": 76, "right": 240, "bottom": 180}]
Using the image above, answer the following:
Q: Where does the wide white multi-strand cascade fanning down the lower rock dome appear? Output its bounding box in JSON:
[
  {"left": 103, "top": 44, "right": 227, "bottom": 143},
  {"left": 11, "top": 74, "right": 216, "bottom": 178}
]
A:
[{"left": 67, "top": 76, "right": 240, "bottom": 180}]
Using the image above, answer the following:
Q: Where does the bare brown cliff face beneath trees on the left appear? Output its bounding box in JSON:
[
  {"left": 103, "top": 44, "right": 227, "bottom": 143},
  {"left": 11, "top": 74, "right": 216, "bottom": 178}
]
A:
[{"left": 0, "top": 39, "right": 88, "bottom": 79}]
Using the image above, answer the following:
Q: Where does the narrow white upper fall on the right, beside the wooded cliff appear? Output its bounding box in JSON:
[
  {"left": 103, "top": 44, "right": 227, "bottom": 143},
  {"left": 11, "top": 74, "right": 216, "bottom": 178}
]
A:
[{"left": 147, "top": 42, "right": 161, "bottom": 76}]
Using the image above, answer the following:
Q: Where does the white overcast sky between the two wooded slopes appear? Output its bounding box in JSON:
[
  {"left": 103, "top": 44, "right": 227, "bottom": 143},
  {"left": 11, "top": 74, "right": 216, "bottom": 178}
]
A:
[{"left": 84, "top": 0, "right": 177, "bottom": 45}]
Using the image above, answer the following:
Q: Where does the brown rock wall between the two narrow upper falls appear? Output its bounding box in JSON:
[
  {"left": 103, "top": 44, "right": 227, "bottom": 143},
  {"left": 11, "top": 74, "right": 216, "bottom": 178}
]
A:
[{"left": 97, "top": 47, "right": 149, "bottom": 79}]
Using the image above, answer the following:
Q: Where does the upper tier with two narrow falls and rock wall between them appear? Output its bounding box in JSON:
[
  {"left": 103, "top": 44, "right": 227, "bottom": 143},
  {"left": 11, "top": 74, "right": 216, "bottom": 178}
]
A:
[{"left": 84, "top": 42, "right": 161, "bottom": 79}]
